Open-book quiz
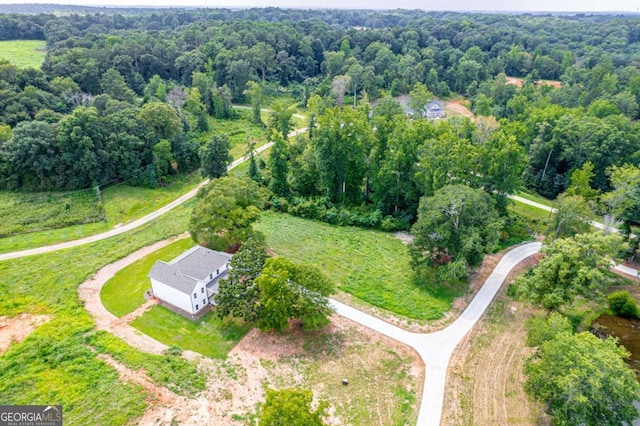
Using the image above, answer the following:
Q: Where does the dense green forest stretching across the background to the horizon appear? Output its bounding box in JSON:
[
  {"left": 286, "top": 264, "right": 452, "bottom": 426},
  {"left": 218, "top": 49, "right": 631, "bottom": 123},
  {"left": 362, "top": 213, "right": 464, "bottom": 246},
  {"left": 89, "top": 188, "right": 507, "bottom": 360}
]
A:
[{"left": 0, "top": 8, "right": 640, "bottom": 233}]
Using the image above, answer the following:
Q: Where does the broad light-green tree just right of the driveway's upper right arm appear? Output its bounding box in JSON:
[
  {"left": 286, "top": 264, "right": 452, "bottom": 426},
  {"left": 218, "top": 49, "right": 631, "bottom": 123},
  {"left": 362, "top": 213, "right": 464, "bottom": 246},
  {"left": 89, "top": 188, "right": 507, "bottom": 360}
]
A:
[{"left": 516, "top": 233, "right": 624, "bottom": 309}]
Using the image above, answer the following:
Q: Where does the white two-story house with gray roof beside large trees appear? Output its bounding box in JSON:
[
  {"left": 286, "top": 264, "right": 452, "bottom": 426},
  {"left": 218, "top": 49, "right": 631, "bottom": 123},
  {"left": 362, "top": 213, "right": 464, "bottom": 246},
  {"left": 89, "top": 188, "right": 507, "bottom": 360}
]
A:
[{"left": 148, "top": 246, "right": 232, "bottom": 319}]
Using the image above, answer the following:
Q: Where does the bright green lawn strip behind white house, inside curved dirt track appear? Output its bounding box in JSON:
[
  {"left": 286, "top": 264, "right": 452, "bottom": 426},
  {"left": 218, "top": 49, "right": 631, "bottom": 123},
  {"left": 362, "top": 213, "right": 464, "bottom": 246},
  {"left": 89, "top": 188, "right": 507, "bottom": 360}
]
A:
[{"left": 100, "top": 238, "right": 194, "bottom": 317}]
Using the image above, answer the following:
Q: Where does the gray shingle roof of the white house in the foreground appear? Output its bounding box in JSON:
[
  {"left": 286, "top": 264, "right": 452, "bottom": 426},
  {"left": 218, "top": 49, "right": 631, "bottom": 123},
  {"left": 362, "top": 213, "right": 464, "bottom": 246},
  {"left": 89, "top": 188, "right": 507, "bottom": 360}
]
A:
[{"left": 148, "top": 246, "right": 232, "bottom": 294}]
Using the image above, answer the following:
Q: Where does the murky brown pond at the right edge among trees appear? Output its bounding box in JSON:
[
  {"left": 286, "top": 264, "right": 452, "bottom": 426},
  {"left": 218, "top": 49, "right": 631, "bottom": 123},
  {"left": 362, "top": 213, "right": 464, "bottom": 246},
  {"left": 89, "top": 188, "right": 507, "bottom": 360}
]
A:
[{"left": 591, "top": 315, "right": 640, "bottom": 381}]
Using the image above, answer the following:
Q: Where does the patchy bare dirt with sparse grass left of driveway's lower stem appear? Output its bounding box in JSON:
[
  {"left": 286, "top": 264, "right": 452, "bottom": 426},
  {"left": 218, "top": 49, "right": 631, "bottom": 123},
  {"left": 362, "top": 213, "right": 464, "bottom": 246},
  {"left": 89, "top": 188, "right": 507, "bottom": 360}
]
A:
[{"left": 126, "top": 315, "right": 424, "bottom": 425}]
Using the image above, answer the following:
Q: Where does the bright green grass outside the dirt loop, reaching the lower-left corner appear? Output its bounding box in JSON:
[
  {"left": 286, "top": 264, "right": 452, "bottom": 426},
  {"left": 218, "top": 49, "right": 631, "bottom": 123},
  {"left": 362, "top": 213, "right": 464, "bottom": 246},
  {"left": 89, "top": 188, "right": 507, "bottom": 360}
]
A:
[{"left": 0, "top": 203, "right": 210, "bottom": 425}]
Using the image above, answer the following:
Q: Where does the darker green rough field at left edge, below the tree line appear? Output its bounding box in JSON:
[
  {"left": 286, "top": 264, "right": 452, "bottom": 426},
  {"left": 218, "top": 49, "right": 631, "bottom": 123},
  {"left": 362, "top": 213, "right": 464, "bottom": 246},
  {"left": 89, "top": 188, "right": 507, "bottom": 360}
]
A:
[{"left": 0, "top": 189, "right": 103, "bottom": 237}]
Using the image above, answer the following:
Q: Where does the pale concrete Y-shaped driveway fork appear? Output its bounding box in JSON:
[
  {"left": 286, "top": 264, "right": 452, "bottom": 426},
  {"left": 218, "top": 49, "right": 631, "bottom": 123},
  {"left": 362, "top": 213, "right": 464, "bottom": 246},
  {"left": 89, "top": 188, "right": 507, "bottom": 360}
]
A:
[{"left": 331, "top": 242, "right": 541, "bottom": 426}]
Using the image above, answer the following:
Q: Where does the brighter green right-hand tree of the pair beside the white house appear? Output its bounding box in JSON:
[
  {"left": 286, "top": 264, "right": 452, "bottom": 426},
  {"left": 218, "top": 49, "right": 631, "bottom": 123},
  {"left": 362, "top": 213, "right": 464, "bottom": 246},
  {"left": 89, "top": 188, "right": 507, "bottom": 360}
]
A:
[{"left": 256, "top": 257, "right": 335, "bottom": 332}]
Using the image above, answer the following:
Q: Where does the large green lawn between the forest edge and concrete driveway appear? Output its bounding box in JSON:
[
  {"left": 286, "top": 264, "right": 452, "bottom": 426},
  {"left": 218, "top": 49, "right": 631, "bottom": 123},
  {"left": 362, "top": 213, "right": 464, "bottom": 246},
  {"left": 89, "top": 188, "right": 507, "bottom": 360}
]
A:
[{"left": 255, "top": 212, "right": 454, "bottom": 320}]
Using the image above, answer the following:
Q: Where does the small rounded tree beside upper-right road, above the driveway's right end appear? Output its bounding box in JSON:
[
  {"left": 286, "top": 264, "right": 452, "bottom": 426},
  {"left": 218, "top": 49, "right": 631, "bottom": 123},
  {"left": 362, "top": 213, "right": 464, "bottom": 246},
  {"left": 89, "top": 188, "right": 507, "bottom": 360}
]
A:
[{"left": 551, "top": 194, "right": 591, "bottom": 239}]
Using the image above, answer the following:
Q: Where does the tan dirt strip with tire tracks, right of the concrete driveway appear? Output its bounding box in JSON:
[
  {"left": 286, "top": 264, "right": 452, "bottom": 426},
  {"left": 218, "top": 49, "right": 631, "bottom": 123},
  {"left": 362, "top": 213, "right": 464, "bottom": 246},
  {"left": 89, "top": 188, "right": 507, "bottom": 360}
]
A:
[{"left": 442, "top": 255, "right": 542, "bottom": 426}]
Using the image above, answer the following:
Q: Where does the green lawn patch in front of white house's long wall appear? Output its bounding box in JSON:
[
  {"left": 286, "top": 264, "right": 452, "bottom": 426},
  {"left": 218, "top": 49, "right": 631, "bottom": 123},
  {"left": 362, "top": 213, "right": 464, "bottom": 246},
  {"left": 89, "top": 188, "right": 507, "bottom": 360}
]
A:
[{"left": 131, "top": 306, "right": 251, "bottom": 359}]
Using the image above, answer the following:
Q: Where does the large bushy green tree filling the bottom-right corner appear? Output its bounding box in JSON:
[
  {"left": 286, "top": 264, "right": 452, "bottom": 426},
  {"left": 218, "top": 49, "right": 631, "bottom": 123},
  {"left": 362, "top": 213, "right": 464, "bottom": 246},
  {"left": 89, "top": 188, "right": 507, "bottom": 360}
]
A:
[{"left": 525, "top": 332, "right": 640, "bottom": 426}]
